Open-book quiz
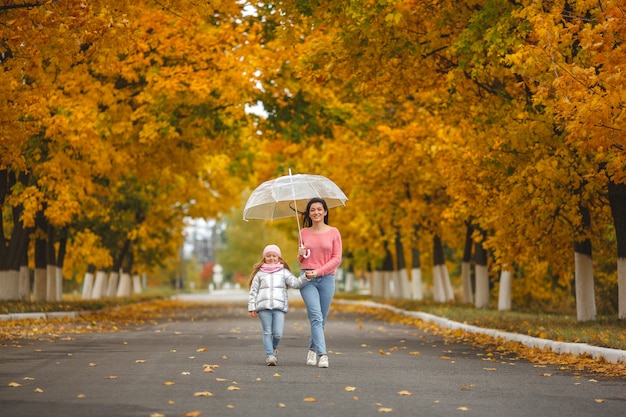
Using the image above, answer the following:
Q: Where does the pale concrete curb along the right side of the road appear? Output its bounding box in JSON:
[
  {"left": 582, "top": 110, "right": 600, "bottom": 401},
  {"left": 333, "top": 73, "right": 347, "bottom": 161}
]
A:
[{"left": 333, "top": 300, "right": 626, "bottom": 363}]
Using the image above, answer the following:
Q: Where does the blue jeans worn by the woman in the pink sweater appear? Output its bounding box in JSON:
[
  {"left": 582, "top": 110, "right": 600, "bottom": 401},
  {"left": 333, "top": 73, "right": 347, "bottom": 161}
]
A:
[{"left": 300, "top": 275, "right": 335, "bottom": 356}]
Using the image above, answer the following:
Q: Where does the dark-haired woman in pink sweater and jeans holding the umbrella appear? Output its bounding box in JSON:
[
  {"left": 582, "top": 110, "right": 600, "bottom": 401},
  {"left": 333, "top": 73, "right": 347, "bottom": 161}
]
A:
[{"left": 298, "top": 198, "right": 342, "bottom": 368}]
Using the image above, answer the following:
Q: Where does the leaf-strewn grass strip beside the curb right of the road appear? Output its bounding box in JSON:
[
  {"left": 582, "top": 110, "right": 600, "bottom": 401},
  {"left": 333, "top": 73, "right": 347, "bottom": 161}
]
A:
[{"left": 337, "top": 294, "right": 626, "bottom": 350}]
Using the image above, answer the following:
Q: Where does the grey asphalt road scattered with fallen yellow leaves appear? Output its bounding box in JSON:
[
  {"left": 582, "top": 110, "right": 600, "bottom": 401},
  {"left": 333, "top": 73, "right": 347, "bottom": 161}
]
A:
[{"left": 0, "top": 290, "right": 626, "bottom": 417}]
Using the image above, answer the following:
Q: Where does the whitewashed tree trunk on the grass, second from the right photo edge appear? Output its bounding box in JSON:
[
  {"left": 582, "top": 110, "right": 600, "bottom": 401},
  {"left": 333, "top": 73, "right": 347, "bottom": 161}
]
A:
[{"left": 574, "top": 206, "right": 596, "bottom": 322}]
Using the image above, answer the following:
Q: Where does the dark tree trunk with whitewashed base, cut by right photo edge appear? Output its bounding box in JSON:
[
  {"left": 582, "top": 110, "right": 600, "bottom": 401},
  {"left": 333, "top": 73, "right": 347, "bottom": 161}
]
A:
[{"left": 609, "top": 181, "right": 626, "bottom": 320}]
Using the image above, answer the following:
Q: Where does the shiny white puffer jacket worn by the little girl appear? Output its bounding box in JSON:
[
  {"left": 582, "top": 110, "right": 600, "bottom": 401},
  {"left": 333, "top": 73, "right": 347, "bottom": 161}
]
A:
[{"left": 248, "top": 268, "right": 309, "bottom": 313}]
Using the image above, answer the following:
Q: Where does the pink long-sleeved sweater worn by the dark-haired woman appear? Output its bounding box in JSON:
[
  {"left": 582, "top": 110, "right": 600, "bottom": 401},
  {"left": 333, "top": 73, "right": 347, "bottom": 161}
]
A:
[{"left": 298, "top": 227, "right": 342, "bottom": 277}]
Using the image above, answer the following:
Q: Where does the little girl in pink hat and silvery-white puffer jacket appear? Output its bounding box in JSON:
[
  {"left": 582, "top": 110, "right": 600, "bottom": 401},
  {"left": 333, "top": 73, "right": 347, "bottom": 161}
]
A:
[{"left": 248, "top": 245, "right": 309, "bottom": 366}]
